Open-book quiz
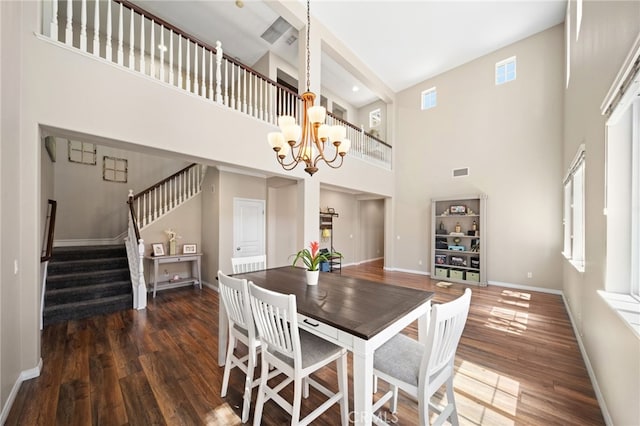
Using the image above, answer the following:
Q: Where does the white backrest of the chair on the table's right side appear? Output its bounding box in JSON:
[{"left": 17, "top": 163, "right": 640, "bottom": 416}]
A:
[{"left": 420, "top": 288, "right": 471, "bottom": 378}]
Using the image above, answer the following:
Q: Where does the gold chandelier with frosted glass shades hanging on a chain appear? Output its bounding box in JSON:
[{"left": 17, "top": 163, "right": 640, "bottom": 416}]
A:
[{"left": 267, "top": 0, "right": 351, "bottom": 176}]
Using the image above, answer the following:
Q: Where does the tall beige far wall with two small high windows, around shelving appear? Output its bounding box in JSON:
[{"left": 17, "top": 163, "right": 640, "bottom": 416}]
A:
[{"left": 393, "top": 26, "right": 564, "bottom": 289}]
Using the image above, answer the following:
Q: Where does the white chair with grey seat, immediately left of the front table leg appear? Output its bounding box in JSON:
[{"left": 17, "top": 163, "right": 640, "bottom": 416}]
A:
[{"left": 249, "top": 282, "right": 349, "bottom": 426}]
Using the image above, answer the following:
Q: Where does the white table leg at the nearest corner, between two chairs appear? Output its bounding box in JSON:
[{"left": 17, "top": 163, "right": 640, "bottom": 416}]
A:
[{"left": 349, "top": 341, "right": 373, "bottom": 426}]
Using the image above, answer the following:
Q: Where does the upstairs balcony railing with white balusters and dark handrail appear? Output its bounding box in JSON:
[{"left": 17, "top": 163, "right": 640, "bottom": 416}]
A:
[{"left": 43, "top": 0, "right": 391, "bottom": 169}]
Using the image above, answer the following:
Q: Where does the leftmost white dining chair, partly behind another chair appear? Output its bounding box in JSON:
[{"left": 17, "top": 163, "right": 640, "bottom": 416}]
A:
[{"left": 218, "top": 271, "right": 260, "bottom": 423}]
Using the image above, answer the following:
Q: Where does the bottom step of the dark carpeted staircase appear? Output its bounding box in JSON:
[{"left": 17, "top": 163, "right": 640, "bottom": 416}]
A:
[{"left": 44, "top": 294, "right": 133, "bottom": 325}]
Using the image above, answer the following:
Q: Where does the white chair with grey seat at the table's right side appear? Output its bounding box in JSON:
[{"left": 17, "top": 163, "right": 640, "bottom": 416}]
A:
[{"left": 373, "top": 288, "right": 471, "bottom": 426}]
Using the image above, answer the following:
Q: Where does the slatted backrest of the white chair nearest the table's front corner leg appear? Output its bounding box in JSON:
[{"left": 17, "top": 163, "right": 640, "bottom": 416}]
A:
[{"left": 249, "top": 281, "right": 301, "bottom": 365}]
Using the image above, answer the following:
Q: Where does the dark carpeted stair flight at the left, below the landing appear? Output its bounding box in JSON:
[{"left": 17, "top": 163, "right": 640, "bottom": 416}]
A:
[{"left": 44, "top": 245, "right": 133, "bottom": 325}]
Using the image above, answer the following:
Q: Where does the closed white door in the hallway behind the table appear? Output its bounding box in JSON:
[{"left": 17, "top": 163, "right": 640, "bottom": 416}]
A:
[{"left": 233, "top": 198, "right": 265, "bottom": 257}]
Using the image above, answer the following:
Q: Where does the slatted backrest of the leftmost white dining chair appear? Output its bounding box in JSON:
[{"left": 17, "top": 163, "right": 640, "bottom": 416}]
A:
[{"left": 218, "top": 271, "right": 255, "bottom": 339}]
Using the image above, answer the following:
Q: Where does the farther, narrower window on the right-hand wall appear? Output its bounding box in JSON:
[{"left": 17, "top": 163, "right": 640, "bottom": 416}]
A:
[{"left": 562, "top": 145, "right": 585, "bottom": 272}]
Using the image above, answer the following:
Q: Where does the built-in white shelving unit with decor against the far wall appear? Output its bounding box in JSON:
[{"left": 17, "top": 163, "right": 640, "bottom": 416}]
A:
[{"left": 431, "top": 195, "right": 487, "bottom": 286}]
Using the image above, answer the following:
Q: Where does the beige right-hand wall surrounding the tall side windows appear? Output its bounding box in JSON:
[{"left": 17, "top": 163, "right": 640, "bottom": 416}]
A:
[{"left": 562, "top": 1, "right": 640, "bottom": 425}]
